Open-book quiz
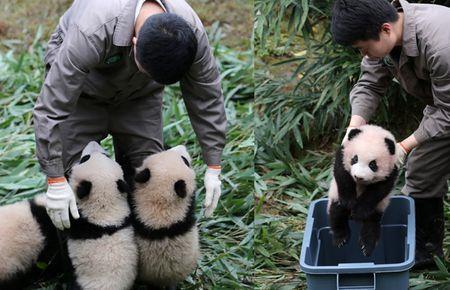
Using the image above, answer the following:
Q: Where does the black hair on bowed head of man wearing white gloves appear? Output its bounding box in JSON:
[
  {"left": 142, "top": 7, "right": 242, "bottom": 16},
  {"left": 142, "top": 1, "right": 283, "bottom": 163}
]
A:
[{"left": 136, "top": 13, "right": 197, "bottom": 85}]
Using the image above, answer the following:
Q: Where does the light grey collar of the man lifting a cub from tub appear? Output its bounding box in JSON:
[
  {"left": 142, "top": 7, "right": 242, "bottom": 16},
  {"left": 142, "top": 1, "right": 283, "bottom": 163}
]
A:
[{"left": 399, "top": 0, "right": 419, "bottom": 57}]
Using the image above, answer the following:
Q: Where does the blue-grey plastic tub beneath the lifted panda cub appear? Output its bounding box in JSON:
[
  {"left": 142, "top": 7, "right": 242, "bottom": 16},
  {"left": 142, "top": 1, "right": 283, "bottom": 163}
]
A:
[{"left": 300, "top": 196, "right": 416, "bottom": 290}]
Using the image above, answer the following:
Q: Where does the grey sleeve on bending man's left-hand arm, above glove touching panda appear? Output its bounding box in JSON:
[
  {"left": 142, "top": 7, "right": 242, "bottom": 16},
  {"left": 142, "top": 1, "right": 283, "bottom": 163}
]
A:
[{"left": 33, "top": 25, "right": 100, "bottom": 177}]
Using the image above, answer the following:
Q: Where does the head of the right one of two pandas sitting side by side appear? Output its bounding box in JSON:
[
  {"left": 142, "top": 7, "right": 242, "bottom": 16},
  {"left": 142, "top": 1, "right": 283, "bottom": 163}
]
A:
[{"left": 133, "top": 146, "right": 196, "bottom": 229}]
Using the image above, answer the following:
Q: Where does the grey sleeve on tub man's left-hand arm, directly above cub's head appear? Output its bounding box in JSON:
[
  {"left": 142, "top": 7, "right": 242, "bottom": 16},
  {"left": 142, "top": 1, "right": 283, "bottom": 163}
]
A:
[{"left": 350, "top": 57, "right": 393, "bottom": 121}]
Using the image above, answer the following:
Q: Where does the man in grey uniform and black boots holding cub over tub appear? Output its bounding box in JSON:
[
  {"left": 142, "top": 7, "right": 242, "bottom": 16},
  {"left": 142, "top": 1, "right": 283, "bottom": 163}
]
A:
[{"left": 331, "top": 0, "right": 450, "bottom": 269}]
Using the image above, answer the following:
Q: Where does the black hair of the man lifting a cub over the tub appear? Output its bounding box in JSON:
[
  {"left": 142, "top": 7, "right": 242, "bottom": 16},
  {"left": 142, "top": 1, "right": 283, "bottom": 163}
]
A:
[{"left": 331, "top": 0, "right": 398, "bottom": 45}]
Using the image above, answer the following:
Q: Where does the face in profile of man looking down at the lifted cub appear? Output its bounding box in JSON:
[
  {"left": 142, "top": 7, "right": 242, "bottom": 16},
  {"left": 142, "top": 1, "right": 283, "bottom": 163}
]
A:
[{"left": 352, "top": 23, "right": 397, "bottom": 59}]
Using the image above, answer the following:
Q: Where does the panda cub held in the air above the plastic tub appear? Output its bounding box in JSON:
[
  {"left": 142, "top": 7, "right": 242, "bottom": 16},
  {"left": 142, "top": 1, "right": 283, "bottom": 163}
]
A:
[{"left": 328, "top": 125, "right": 398, "bottom": 256}]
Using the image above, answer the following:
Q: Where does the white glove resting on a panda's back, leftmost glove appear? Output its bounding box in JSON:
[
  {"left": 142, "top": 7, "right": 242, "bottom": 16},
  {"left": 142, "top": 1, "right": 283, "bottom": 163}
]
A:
[{"left": 46, "top": 178, "right": 80, "bottom": 230}]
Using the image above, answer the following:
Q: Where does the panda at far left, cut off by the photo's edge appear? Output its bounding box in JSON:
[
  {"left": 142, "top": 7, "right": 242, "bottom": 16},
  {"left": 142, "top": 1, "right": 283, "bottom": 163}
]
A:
[{"left": 0, "top": 194, "right": 64, "bottom": 290}]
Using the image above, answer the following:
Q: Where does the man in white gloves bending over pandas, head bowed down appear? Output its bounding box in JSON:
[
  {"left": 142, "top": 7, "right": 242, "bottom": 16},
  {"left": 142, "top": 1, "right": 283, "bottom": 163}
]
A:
[{"left": 33, "top": 0, "right": 226, "bottom": 229}]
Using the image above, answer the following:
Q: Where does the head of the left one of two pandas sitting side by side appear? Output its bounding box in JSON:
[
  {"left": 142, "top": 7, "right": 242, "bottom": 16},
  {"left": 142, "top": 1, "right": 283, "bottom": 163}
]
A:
[{"left": 70, "top": 142, "right": 130, "bottom": 225}]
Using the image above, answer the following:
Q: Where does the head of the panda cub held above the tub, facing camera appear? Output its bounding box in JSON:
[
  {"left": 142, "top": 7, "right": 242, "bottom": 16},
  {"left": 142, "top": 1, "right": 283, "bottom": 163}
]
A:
[{"left": 342, "top": 125, "right": 397, "bottom": 184}]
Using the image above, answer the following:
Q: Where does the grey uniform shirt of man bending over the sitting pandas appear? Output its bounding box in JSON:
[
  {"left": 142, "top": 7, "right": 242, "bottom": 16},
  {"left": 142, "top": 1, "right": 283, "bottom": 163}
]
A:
[{"left": 33, "top": 0, "right": 226, "bottom": 177}]
